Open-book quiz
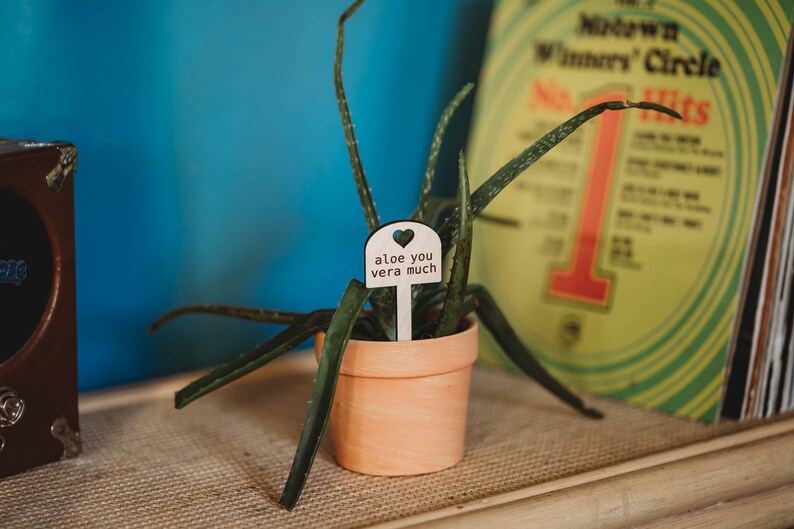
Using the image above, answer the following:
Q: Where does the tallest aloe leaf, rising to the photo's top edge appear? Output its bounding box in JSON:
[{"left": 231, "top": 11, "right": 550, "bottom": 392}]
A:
[{"left": 334, "top": 0, "right": 380, "bottom": 231}]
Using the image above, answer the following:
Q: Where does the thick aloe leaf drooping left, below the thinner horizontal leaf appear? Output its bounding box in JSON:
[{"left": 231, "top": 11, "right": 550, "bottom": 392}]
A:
[{"left": 175, "top": 309, "right": 334, "bottom": 408}]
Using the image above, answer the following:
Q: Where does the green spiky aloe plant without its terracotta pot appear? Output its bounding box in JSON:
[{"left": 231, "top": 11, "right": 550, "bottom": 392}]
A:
[{"left": 149, "top": 0, "right": 681, "bottom": 510}]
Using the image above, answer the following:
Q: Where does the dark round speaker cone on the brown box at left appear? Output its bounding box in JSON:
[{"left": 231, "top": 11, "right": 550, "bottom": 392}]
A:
[{"left": 0, "top": 189, "right": 53, "bottom": 363}]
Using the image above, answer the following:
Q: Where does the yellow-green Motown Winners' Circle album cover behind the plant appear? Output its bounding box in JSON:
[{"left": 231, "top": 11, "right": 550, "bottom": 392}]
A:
[{"left": 467, "top": 0, "right": 794, "bottom": 421}]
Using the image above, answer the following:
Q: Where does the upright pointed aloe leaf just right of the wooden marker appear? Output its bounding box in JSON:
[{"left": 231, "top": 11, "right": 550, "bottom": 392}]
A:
[{"left": 435, "top": 151, "right": 472, "bottom": 338}]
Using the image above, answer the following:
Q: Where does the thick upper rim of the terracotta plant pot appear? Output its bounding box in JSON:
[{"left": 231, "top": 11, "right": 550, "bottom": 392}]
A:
[{"left": 314, "top": 318, "right": 479, "bottom": 378}]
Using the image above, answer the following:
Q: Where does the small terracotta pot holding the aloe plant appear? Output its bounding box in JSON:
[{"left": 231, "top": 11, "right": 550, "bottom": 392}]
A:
[{"left": 314, "top": 321, "right": 477, "bottom": 476}]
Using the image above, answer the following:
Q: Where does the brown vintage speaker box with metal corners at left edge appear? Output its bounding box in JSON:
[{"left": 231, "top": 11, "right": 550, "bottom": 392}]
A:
[{"left": 0, "top": 139, "right": 80, "bottom": 476}]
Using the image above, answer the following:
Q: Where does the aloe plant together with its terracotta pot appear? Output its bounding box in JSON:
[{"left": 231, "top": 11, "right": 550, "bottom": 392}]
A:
[{"left": 149, "top": 0, "right": 680, "bottom": 510}]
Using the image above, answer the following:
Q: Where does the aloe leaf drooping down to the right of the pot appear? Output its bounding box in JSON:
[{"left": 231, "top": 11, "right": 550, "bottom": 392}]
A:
[{"left": 470, "top": 285, "right": 604, "bottom": 419}]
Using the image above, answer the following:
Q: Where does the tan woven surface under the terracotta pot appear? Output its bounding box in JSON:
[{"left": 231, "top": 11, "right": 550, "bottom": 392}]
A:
[{"left": 0, "top": 355, "right": 780, "bottom": 528}]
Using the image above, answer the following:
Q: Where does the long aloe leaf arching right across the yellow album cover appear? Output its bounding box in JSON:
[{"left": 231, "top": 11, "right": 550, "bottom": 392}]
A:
[{"left": 438, "top": 101, "right": 681, "bottom": 255}]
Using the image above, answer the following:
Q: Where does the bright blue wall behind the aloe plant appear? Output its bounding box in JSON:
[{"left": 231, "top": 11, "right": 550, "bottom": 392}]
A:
[{"left": 0, "top": 0, "right": 491, "bottom": 389}]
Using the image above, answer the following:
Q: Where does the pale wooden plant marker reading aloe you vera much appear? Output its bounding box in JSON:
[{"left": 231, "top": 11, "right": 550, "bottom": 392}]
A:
[{"left": 364, "top": 220, "right": 441, "bottom": 342}]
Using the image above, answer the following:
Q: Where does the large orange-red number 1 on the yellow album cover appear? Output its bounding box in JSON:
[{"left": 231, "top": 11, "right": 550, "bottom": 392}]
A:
[{"left": 548, "top": 91, "right": 626, "bottom": 307}]
